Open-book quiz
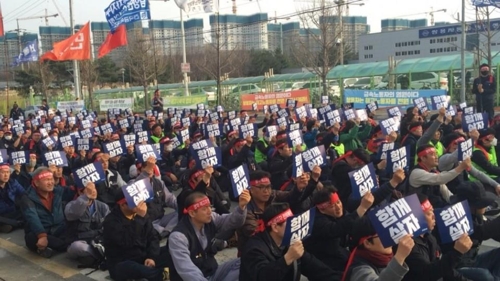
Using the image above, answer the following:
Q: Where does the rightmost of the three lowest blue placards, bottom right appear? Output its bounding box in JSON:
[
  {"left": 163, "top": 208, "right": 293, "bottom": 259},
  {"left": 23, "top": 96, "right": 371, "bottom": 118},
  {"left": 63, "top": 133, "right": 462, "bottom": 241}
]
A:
[{"left": 434, "top": 200, "right": 474, "bottom": 244}]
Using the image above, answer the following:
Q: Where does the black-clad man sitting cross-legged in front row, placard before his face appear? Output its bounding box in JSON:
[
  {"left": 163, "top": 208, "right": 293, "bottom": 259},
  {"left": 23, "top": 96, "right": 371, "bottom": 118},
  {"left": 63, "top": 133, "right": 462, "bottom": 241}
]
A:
[{"left": 103, "top": 189, "right": 167, "bottom": 281}]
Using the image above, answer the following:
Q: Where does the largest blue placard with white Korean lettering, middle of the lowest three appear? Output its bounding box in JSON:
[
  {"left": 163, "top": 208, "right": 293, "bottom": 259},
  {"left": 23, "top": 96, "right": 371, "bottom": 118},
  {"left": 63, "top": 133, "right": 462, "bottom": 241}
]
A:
[{"left": 368, "top": 194, "right": 429, "bottom": 248}]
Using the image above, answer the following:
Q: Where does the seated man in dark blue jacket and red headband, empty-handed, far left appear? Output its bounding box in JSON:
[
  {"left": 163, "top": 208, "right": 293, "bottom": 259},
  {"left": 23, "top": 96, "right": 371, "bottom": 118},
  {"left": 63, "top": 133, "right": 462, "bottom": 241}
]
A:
[{"left": 21, "top": 167, "right": 73, "bottom": 258}]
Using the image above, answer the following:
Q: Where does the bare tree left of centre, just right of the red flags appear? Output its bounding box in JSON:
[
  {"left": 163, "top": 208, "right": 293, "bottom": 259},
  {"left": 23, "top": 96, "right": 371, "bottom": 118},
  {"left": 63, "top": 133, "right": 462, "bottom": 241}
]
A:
[{"left": 124, "top": 30, "right": 167, "bottom": 109}]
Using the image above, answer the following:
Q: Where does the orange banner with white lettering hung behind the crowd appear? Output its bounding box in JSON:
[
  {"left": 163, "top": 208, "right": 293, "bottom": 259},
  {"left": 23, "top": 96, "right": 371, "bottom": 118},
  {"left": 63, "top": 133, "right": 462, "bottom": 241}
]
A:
[{"left": 241, "top": 90, "right": 310, "bottom": 110}]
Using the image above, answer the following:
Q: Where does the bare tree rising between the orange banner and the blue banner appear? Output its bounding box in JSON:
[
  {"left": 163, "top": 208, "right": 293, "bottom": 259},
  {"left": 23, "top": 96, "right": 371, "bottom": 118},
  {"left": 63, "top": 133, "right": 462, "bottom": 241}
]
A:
[{"left": 291, "top": 0, "right": 343, "bottom": 98}]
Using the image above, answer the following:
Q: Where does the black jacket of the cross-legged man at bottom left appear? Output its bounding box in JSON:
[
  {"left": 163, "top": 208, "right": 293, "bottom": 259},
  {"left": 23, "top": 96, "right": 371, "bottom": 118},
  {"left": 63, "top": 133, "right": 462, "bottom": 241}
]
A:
[{"left": 103, "top": 207, "right": 160, "bottom": 268}]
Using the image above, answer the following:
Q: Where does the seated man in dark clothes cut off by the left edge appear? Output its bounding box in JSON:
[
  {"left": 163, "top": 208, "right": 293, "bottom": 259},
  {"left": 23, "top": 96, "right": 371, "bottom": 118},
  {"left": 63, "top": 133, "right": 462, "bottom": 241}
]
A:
[{"left": 0, "top": 164, "right": 24, "bottom": 233}]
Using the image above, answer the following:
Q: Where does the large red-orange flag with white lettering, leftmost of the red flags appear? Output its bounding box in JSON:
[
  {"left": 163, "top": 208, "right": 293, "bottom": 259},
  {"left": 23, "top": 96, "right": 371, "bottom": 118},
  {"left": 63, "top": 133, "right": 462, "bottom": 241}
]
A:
[{"left": 40, "top": 22, "right": 90, "bottom": 61}]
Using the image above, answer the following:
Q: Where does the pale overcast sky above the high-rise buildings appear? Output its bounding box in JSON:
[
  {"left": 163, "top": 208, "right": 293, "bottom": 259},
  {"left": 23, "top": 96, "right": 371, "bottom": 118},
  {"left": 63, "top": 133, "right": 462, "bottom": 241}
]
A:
[{"left": 0, "top": 0, "right": 500, "bottom": 32}]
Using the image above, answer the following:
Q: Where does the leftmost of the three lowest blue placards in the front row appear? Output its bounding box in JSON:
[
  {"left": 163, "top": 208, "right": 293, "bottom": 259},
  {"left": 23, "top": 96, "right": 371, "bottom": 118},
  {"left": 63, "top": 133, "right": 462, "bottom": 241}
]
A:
[{"left": 281, "top": 208, "right": 316, "bottom": 246}]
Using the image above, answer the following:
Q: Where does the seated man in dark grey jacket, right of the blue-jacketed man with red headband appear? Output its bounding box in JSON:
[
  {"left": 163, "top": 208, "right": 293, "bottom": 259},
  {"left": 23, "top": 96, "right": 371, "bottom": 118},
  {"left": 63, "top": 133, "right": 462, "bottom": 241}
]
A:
[{"left": 64, "top": 182, "right": 109, "bottom": 266}]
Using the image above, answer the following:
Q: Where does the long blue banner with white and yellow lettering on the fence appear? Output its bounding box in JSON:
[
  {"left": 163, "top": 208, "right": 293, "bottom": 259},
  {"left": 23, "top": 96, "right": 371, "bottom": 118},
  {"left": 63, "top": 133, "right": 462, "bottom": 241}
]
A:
[{"left": 344, "top": 90, "right": 446, "bottom": 108}]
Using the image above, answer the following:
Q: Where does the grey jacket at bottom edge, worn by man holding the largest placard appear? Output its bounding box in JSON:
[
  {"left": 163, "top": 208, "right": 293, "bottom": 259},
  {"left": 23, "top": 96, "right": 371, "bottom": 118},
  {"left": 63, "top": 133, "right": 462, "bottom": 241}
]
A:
[{"left": 349, "top": 258, "right": 410, "bottom": 281}]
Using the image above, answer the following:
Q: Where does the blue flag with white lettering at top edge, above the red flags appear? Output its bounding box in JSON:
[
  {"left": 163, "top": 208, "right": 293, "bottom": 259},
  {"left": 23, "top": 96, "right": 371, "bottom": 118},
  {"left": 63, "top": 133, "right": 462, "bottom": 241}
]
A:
[{"left": 104, "top": 0, "right": 151, "bottom": 32}]
